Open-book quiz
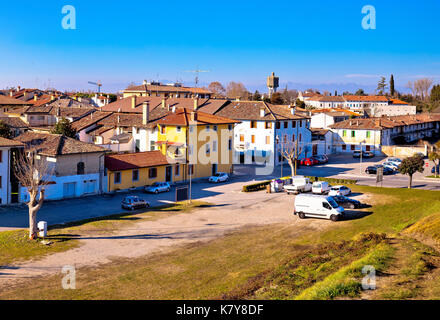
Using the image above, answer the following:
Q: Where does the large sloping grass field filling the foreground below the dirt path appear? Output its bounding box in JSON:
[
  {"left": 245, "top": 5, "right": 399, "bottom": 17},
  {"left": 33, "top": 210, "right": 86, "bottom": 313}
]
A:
[{"left": 0, "top": 186, "right": 440, "bottom": 299}]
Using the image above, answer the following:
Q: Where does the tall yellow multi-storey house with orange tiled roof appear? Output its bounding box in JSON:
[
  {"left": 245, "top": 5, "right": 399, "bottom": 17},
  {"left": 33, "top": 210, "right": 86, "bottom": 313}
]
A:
[{"left": 155, "top": 108, "right": 239, "bottom": 180}]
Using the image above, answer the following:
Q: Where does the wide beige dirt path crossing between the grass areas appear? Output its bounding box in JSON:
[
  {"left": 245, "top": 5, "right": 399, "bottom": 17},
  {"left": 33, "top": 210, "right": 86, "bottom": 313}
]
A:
[{"left": 0, "top": 193, "right": 332, "bottom": 289}]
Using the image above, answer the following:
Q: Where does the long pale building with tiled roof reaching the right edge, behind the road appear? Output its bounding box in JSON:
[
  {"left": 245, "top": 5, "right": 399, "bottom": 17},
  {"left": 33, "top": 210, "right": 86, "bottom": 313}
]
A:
[{"left": 330, "top": 114, "right": 440, "bottom": 155}]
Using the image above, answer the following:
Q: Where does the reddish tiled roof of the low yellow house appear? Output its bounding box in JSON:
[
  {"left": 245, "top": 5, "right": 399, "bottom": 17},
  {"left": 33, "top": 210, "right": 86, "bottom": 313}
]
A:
[{"left": 105, "top": 151, "right": 170, "bottom": 171}]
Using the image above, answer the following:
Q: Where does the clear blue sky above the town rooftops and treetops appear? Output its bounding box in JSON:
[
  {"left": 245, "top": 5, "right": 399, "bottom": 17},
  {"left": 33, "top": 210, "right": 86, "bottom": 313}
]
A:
[{"left": 0, "top": 0, "right": 440, "bottom": 91}]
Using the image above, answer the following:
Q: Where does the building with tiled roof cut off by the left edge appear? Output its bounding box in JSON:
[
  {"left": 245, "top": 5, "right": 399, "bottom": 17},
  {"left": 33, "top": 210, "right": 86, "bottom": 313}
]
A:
[{"left": 0, "top": 137, "right": 23, "bottom": 205}]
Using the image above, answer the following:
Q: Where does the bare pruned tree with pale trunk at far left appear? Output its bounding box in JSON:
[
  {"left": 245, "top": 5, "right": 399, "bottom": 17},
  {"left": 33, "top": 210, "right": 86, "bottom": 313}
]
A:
[{"left": 15, "top": 151, "right": 52, "bottom": 240}]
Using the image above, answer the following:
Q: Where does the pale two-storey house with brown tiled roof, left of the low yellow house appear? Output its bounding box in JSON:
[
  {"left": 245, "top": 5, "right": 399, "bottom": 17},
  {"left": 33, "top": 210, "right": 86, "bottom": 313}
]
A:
[{"left": 15, "top": 132, "right": 106, "bottom": 202}]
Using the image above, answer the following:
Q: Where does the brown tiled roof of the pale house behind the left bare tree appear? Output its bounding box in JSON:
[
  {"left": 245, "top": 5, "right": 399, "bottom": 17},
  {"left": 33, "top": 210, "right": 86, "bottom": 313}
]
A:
[{"left": 14, "top": 131, "right": 107, "bottom": 157}]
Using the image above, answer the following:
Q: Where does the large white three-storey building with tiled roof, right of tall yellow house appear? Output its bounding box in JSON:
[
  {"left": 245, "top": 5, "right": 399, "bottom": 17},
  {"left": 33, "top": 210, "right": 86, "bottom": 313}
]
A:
[{"left": 215, "top": 101, "right": 312, "bottom": 165}]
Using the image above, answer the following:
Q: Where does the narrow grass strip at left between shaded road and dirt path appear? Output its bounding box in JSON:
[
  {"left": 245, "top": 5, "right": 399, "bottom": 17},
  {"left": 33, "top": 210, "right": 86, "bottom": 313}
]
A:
[{"left": 0, "top": 201, "right": 210, "bottom": 265}]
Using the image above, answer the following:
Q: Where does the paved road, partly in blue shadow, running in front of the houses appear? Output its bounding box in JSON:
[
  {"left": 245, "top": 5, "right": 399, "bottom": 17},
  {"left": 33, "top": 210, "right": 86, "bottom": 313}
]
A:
[{"left": 0, "top": 156, "right": 440, "bottom": 231}]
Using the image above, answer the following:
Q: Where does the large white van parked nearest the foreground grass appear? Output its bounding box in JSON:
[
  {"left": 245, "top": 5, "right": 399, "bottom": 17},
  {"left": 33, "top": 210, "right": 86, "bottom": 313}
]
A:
[{"left": 294, "top": 194, "right": 344, "bottom": 221}]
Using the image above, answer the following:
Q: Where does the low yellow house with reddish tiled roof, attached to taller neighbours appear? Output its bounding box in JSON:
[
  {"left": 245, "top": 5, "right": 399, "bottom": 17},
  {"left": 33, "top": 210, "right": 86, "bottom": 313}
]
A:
[{"left": 105, "top": 151, "right": 183, "bottom": 191}]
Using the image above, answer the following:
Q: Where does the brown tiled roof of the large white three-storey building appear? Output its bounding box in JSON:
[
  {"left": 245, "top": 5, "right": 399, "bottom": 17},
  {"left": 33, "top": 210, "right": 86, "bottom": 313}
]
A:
[{"left": 216, "top": 101, "right": 306, "bottom": 121}]
